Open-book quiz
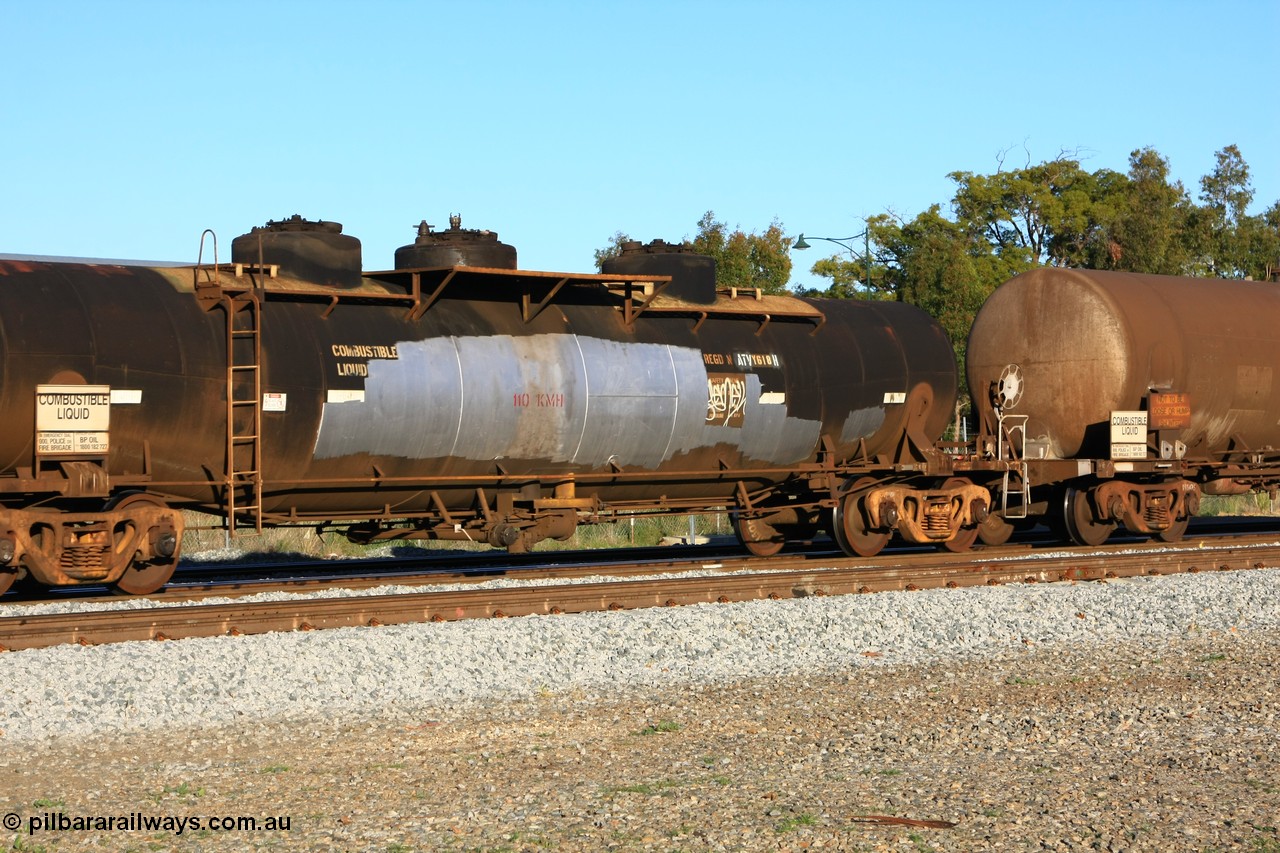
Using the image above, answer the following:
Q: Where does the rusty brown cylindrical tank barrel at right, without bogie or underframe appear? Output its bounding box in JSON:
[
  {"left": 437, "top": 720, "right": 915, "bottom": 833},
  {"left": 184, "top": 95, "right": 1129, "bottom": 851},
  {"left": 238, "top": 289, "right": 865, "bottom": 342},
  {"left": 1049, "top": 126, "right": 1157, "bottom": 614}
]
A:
[{"left": 966, "top": 268, "right": 1280, "bottom": 459}]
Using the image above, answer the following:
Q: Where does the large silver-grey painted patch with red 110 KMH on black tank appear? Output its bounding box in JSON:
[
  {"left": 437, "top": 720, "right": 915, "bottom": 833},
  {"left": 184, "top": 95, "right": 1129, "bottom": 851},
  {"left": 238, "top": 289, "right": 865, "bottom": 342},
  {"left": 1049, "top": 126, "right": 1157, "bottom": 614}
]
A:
[{"left": 315, "top": 334, "right": 824, "bottom": 467}]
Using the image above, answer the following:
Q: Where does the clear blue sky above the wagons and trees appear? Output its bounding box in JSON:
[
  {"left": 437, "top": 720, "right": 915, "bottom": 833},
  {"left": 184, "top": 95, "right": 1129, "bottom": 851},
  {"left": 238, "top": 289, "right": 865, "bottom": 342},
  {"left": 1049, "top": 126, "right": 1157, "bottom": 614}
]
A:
[{"left": 0, "top": 0, "right": 1280, "bottom": 286}]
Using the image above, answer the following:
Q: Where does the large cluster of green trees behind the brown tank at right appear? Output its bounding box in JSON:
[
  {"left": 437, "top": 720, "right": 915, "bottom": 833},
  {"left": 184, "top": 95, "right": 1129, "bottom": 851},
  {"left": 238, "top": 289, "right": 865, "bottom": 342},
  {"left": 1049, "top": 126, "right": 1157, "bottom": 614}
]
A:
[{"left": 806, "top": 145, "right": 1280, "bottom": 417}]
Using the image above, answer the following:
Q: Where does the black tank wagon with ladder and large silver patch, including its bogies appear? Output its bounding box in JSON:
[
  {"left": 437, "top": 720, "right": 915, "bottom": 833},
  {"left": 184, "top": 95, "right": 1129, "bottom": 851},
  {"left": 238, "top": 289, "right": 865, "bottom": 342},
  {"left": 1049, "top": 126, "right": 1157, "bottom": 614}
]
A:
[{"left": 0, "top": 218, "right": 967, "bottom": 592}]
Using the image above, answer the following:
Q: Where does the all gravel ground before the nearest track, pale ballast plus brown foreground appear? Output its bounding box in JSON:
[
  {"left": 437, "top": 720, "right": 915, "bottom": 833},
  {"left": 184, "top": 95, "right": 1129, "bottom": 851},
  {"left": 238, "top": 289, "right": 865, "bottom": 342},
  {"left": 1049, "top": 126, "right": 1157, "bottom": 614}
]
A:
[{"left": 0, "top": 570, "right": 1280, "bottom": 853}]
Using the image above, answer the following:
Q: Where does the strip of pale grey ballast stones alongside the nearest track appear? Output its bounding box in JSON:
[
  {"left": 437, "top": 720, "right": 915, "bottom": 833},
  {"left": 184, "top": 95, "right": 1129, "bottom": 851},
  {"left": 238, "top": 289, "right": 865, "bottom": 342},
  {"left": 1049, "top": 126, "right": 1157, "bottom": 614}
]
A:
[{"left": 0, "top": 570, "right": 1280, "bottom": 743}]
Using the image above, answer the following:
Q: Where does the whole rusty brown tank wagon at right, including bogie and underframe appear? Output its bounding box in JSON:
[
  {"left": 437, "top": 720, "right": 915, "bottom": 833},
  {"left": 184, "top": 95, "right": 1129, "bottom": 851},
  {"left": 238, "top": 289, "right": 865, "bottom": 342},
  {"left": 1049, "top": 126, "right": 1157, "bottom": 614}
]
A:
[{"left": 966, "top": 268, "right": 1280, "bottom": 546}]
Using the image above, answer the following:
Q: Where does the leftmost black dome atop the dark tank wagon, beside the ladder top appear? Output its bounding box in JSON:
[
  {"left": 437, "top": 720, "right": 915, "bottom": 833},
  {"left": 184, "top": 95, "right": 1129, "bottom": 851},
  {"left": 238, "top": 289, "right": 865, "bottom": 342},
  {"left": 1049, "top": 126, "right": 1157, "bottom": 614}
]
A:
[{"left": 232, "top": 214, "right": 364, "bottom": 287}]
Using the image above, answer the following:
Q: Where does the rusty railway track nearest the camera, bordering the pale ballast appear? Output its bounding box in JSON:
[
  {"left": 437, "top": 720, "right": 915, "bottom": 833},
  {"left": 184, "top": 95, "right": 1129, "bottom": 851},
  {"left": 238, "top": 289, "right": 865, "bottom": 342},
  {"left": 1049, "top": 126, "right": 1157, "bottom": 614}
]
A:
[{"left": 0, "top": 535, "right": 1280, "bottom": 651}]
